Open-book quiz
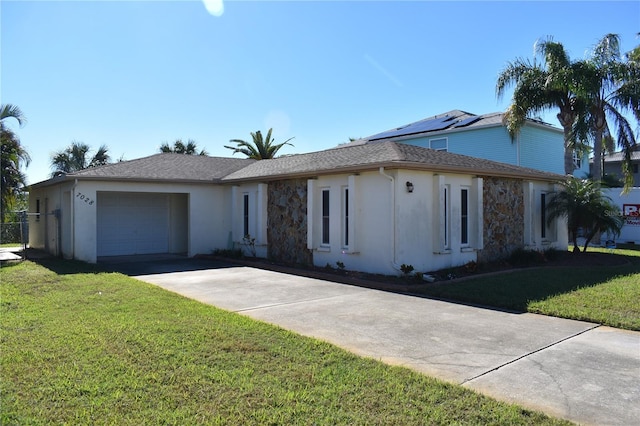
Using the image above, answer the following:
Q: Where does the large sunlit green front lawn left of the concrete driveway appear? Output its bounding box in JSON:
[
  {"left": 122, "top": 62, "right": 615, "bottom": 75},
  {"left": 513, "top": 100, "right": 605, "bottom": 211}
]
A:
[{"left": 0, "top": 260, "right": 566, "bottom": 425}]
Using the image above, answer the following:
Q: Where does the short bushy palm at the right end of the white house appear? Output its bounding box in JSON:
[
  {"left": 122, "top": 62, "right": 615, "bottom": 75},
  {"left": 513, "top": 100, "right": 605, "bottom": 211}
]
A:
[{"left": 547, "top": 177, "right": 624, "bottom": 253}]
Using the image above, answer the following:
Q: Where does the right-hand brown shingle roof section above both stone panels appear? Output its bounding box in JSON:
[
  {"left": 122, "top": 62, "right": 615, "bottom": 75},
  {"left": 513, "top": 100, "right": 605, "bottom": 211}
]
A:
[{"left": 222, "top": 142, "right": 562, "bottom": 182}]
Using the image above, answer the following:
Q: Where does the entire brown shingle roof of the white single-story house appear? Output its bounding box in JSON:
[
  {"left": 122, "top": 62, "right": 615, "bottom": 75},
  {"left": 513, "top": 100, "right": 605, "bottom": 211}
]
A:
[{"left": 34, "top": 142, "right": 562, "bottom": 187}]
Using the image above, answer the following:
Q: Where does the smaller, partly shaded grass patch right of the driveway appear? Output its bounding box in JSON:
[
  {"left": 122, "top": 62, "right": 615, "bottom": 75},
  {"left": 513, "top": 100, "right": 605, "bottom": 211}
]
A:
[{"left": 416, "top": 247, "right": 640, "bottom": 330}]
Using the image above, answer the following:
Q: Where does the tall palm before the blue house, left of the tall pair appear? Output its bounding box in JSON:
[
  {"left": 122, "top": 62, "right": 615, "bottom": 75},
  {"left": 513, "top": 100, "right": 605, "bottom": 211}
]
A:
[{"left": 496, "top": 39, "right": 585, "bottom": 175}]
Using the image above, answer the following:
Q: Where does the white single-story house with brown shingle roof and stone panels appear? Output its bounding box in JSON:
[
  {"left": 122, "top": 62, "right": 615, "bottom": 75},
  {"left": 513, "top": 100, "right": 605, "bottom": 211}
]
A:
[{"left": 29, "top": 141, "right": 568, "bottom": 274}]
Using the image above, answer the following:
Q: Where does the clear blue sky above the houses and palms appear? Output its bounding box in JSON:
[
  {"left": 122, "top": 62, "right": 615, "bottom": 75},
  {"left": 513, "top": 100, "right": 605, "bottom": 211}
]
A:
[{"left": 0, "top": 0, "right": 640, "bottom": 183}]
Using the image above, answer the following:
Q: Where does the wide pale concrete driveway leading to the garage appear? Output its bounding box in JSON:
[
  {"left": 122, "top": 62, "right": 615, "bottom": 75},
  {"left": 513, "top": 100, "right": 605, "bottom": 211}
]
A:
[{"left": 107, "top": 260, "right": 640, "bottom": 425}]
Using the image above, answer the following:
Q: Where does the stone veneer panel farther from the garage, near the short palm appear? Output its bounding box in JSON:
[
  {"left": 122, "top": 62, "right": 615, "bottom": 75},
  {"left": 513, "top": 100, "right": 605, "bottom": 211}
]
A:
[{"left": 478, "top": 177, "right": 524, "bottom": 262}]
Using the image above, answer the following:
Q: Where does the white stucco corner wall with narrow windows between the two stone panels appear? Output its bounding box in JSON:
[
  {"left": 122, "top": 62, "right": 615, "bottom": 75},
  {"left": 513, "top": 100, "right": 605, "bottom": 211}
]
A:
[{"left": 309, "top": 170, "right": 481, "bottom": 274}]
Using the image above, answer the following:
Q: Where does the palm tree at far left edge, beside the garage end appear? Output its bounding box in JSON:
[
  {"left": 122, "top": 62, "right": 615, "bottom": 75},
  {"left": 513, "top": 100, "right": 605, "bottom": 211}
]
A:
[{"left": 0, "top": 104, "right": 31, "bottom": 223}]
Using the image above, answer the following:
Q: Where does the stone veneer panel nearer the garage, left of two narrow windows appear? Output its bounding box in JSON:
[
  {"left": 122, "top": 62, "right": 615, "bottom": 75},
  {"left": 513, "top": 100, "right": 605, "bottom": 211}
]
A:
[{"left": 267, "top": 179, "right": 313, "bottom": 265}]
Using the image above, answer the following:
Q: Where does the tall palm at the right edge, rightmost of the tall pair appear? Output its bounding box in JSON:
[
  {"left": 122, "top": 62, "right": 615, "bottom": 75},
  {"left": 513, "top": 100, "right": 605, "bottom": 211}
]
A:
[{"left": 574, "top": 34, "right": 640, "bottom": 191}]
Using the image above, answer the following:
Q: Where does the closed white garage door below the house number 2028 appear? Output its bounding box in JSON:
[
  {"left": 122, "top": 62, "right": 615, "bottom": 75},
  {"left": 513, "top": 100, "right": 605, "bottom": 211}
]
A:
[{"left": 97, "top": 192, "right": 170, "bottom": 256}]
